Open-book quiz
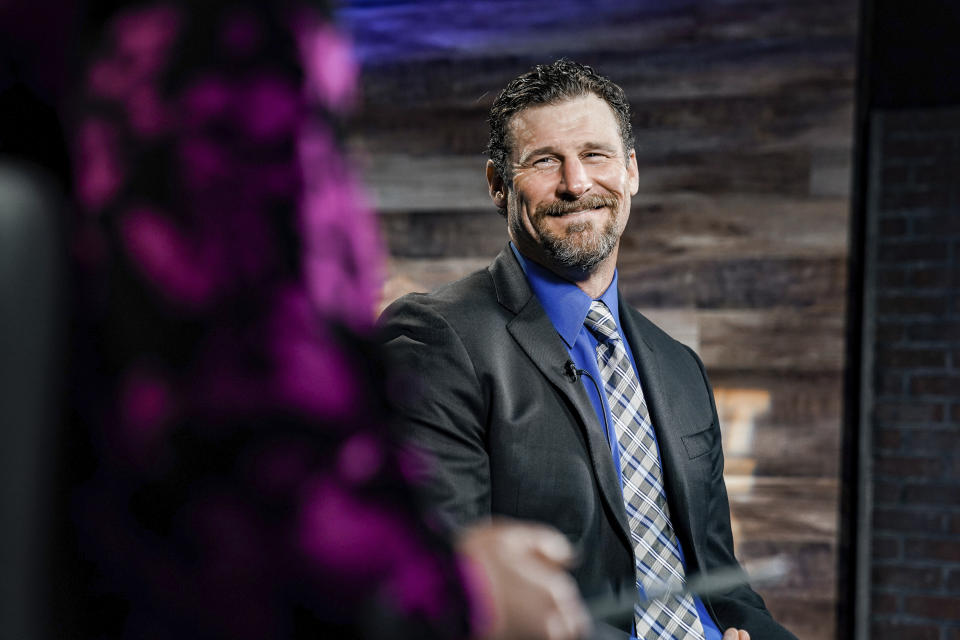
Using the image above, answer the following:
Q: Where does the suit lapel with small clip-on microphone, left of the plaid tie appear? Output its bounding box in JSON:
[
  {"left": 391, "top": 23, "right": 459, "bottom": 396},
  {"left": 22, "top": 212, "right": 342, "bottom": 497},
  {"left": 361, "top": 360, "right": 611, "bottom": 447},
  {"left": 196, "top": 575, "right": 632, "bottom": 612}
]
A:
[{"left": 489, "top": 245, "right": 633, "bottom": 549}]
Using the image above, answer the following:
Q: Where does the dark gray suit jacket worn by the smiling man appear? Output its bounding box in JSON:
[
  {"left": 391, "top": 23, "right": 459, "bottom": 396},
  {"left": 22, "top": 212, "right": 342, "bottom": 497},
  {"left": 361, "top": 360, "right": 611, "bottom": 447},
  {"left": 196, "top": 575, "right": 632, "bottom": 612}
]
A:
[{"left": 381, "top": 246, "right": 794, "bottom": 640}]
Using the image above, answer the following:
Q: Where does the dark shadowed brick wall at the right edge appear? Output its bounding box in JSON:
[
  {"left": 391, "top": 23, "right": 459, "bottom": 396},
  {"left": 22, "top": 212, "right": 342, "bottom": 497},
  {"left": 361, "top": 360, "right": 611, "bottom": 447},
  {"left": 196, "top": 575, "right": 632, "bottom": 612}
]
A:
[{"left": 864, "top": 108, "right": 960, "bottom": 640}]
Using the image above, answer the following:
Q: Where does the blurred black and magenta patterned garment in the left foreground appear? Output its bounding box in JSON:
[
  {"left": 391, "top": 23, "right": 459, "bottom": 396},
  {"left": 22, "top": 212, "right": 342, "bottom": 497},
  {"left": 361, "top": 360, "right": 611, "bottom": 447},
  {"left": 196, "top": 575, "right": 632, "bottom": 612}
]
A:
[{"left": 64, "top": 2, "right": 469, "bottom": 638}]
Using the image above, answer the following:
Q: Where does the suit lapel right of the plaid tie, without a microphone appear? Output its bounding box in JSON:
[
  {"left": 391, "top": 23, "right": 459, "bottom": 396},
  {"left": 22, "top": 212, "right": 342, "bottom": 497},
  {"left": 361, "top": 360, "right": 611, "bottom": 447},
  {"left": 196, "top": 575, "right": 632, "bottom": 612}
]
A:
[{"left": 620, "top": 304, "right": 703, "bottom": 566}]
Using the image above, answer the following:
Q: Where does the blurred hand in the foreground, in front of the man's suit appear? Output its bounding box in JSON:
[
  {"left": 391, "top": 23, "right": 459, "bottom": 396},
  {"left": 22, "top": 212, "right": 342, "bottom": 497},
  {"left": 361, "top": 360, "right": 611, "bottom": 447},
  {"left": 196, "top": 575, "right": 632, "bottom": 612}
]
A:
[{"left": 457, "top": 519, "right": 591, "bottom": 640}]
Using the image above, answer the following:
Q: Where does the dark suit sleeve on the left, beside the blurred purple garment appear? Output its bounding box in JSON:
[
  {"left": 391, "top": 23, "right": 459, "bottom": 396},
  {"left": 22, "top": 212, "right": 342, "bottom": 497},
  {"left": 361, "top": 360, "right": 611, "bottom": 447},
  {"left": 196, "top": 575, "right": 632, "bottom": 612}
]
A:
[{"left": 380, "top": 294, "right": 490, "bottom": 528}]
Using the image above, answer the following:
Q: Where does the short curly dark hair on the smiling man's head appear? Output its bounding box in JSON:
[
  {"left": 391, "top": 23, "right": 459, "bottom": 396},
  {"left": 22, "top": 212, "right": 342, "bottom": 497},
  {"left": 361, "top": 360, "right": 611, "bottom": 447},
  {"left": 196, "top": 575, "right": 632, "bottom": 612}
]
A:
[{"left": 487, "top": 58, "right": 634, "bottom": 181}]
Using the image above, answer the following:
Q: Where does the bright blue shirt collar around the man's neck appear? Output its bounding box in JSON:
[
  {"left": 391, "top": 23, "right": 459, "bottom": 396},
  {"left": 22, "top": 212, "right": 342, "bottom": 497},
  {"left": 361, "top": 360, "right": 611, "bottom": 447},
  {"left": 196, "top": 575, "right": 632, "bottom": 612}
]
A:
[{"left": 510, "top": 242, "right": 620, "bottom": 348}]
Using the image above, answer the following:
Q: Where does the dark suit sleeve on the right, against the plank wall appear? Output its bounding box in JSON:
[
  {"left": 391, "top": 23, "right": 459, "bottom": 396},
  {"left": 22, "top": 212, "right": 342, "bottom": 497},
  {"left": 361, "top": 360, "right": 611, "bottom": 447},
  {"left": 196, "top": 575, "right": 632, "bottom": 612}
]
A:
[{"left": 687, "top": 347, "right": 797, "bottom": 640}]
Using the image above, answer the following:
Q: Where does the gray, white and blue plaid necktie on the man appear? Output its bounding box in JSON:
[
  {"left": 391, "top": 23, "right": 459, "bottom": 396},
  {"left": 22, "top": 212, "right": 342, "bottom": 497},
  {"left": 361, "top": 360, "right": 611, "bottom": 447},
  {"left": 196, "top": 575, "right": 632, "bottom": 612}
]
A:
[{"left": 584, "top": 300, "right": 704, "bottom": 640}]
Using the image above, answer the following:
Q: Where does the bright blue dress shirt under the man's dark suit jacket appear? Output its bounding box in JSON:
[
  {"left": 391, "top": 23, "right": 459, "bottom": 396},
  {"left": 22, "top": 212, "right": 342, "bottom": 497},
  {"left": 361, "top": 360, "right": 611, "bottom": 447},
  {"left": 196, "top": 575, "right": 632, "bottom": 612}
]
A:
[{"left": 510, "top": 242, "right": 723, "bottom": 640}]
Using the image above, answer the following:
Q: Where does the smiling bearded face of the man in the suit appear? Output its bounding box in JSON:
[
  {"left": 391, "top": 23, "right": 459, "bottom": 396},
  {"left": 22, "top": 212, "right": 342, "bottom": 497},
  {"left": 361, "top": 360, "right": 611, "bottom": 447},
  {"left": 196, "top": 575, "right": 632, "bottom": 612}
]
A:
[{"left": 487, "top": 94, "right": 639, "bottom": 273}]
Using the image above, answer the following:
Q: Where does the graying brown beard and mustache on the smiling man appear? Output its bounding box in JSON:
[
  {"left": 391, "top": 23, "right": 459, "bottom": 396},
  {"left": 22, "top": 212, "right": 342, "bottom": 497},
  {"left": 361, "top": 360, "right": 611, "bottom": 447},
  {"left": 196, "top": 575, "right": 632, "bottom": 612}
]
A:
[{"left": 531, "top": 194, "right": 620, "bottom": 273}]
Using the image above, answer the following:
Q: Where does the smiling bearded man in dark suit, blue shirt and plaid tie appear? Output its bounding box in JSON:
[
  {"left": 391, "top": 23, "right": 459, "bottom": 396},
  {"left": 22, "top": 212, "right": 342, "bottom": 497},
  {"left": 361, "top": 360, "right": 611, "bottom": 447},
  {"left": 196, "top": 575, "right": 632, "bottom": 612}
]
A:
[{"left": 382, "top": 60, "right": 794, "bottom": 640}]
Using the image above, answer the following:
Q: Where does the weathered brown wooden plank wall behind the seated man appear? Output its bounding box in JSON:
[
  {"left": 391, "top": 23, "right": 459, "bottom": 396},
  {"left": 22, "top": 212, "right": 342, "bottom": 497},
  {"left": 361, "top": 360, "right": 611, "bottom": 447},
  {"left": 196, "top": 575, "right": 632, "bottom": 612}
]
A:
[{"left": 340, "top": 0, "right": 857, "bottom": 640}]
